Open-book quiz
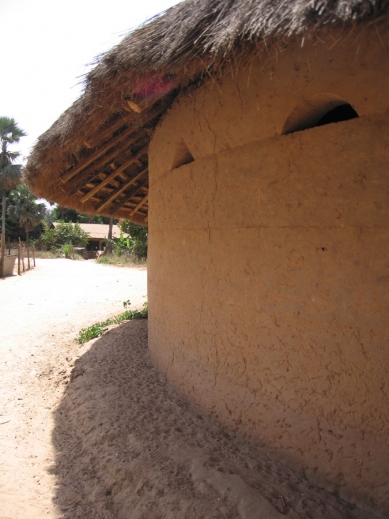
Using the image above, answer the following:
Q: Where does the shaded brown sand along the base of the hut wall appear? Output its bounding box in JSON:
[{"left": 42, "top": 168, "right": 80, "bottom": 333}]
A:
[{"left": 51, "top": 321, "right": 374, "bottom": 519}]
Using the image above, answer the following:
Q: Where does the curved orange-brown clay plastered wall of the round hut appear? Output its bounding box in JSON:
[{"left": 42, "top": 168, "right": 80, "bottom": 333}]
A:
[{"left": 149, "top": 31, "right": 389, "bottom": 516}]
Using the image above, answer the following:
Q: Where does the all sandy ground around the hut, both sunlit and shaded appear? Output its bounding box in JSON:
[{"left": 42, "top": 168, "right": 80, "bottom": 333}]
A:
[{"left": 0, "top": 259, "right": 375, "bottom": 519}]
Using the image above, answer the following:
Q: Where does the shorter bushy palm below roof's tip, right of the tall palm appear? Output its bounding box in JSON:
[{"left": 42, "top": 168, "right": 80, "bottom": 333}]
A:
[{"left": 8, "top": 184, "right": 46, "bottom": 243}]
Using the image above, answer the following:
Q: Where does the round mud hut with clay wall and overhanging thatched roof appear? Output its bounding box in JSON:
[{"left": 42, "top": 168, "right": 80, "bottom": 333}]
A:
[{"left": 27, "top": 0, "right": 389, "bottom": 517}]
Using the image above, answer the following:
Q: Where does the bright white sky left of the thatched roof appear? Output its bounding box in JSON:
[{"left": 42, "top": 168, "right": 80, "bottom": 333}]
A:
[{"left": 0, "top": 0, "right": 179, "bottom": 161}]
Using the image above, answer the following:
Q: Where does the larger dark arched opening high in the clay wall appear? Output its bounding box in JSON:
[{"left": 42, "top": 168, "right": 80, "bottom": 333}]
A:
[{"left": 282, "top": 94, "right": 359, "bottom": 135}]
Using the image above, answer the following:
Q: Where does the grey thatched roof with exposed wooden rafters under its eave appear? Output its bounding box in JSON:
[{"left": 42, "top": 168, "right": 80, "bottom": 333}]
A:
[{"left": 25, "top": 0, "right": 389, "bottom": 224}]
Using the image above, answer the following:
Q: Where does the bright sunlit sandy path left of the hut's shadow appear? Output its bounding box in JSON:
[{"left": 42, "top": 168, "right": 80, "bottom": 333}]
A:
[{"left": 0, "top": 259, "right": 147, "bottom": 519}]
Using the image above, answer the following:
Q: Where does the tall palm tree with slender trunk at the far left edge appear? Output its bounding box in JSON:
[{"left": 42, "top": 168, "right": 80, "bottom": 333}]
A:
[{"left": 0, "top": 117, "right": 26, "bottom": 273}]
